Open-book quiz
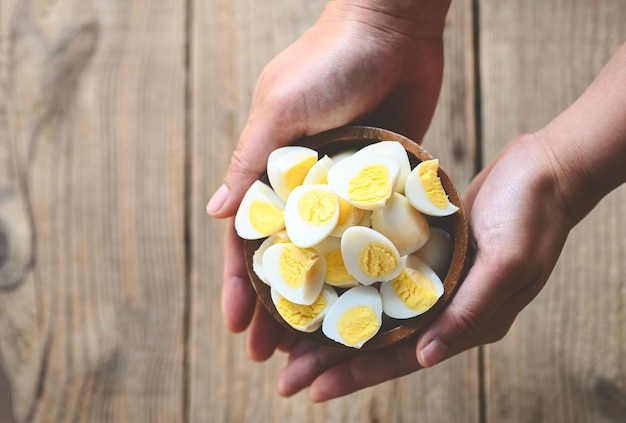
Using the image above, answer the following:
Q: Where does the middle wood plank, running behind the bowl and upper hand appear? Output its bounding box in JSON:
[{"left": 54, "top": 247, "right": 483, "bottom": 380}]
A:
[{"left": 189, "top": 0, "right": 479, "bottom": 422}]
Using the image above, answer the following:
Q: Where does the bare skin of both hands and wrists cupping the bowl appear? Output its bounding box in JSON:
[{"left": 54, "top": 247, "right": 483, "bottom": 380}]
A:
[{"left": 207, "top": 0, "right": 626, "bottom": 402}]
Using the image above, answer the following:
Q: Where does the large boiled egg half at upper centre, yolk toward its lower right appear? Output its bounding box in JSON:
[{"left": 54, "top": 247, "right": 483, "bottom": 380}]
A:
[{"left": 328, "top": 153, "right": 400, "bottom": 210}]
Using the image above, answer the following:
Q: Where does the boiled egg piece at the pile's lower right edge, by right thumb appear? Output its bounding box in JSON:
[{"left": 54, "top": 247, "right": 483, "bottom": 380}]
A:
[{"left": 380, "top": 255, "right": 443, "bottom": 319}]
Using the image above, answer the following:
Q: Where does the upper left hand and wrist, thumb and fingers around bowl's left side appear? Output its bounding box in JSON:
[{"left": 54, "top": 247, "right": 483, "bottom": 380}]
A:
[{"left": 207, "top": 0, "right": 449, "bottom": 360}]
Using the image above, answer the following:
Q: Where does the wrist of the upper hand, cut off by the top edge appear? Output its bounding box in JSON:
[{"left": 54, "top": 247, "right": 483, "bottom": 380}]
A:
[{"left": 328, "top": 0, "right": 451, "bottom": 39}]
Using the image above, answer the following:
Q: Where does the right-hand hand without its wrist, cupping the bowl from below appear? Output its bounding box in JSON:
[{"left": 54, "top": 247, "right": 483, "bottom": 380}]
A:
[{"left": 278, "top": 135, "right": 575, "bottom": 401}]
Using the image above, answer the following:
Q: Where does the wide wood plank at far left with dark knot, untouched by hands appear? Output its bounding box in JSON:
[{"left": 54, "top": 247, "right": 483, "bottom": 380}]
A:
[{"left": 0, "top": 0, "right": 185, "bottom": 422}]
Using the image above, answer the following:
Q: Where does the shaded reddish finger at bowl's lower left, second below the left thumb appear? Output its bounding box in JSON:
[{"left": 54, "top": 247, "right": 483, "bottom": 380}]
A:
[{"left": 248, "top": 301, "right": 284, "bottom": 361}]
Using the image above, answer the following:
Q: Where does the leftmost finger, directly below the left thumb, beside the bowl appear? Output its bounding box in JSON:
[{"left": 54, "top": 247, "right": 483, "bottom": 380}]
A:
[{"left": 222, "top": 219, "right": 256, "bottom": 332}]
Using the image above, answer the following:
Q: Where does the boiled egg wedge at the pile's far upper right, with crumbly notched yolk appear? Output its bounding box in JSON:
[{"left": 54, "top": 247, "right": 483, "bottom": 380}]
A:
[{"left": 405, "top": 159, "right": 459, "bottom": 216}]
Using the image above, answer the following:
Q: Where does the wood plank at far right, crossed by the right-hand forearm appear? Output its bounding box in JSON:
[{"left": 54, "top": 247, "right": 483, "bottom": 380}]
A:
[{"left": 480, "top": 0, "right": 626, "bottom": 423}]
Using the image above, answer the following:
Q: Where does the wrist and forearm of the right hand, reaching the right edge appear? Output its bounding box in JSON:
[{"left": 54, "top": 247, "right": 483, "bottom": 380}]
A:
[{"left": 536, "top": 44, "right": 626, "bottom": 227}]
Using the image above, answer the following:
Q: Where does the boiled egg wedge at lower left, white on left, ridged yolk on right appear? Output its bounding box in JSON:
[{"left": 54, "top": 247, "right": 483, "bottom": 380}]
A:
[{"left": 262, "top": 243, "right": 326, "bottom": 305}]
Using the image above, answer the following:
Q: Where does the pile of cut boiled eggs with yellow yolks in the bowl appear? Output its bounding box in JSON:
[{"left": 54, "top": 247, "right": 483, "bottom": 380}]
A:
[{"left": 235, "top": 141, "right": 458, "bottom": 348}]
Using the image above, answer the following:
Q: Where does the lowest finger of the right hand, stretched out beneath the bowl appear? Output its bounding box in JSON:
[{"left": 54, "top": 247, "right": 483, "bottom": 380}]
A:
[{"left": 309, "top": 340, "right": 421, "bottom": 402}]
